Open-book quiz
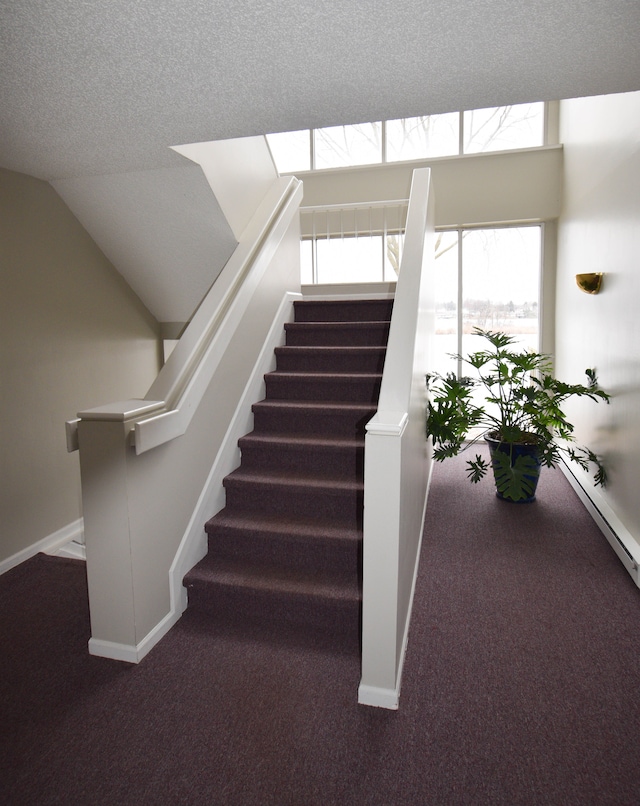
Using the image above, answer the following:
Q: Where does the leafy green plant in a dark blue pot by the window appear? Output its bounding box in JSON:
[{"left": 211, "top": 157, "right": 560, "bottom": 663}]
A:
[{"left": 427, "top": 328, "right": 609, "bottom": 502}]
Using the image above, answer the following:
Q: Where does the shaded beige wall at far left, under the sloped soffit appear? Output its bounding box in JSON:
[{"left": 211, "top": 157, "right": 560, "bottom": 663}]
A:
[{"left": 0, "top": 169, "right": 159, "bottom": 562}]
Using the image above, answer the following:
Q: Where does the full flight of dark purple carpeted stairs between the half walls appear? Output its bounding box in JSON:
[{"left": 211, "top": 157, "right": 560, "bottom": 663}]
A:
[{"left": 185, "top": 300, "right": 393, "bottom": 652}]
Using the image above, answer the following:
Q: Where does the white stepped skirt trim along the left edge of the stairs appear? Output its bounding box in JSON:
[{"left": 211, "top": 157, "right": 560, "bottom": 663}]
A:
[{"left": 169, "top": 292, "right": 302, "bottom": 613}]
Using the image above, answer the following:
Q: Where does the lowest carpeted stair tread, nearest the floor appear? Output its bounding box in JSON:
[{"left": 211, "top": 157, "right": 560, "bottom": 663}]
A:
[{"left": 187, "top": 558, "right": 360, "bottom": 602}]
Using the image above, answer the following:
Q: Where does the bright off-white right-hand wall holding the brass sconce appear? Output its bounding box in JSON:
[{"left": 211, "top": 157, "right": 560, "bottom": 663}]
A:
[{"left": 556, "top": 92, "right": 640, "bottom": 541}]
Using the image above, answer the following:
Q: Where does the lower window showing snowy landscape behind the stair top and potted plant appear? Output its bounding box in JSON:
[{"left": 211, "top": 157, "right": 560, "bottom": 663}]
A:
[{"left": 302, "top": 225, "right": 542, "bottom": 373}]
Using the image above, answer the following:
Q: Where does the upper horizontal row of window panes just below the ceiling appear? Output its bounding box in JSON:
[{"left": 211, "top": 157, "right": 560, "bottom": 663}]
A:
[{"left": 267, "top": 103, "right": 545, "bottom": 173}]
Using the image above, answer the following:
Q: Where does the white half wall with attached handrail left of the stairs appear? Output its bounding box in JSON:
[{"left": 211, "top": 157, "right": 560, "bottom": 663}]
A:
[{"left": 68, "top": 177, "right": 302, "bottom": 662}]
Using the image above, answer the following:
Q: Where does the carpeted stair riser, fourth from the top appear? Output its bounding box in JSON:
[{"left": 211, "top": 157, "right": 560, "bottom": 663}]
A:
[{"left": 265, "top": 374, "right": 381, "bottom": 404}]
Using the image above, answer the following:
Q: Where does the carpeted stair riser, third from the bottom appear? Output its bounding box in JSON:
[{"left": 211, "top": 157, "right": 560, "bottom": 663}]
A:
[{"left": 225, "top": 479, "right": 363, "bottom": 528}]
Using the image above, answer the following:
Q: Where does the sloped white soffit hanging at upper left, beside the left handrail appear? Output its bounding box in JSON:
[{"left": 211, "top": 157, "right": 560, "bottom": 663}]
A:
[{"left": 52, "top": 164, "right": 236, "bottom": 324}]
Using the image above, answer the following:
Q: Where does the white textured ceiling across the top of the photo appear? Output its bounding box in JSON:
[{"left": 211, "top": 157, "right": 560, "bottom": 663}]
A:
[{"left": 0, "top": 0, "right": 640, "bottom": 180}]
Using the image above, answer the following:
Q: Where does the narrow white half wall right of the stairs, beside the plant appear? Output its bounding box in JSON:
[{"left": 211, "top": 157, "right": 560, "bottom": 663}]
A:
[{"left": 358, "top": 168, "right": 434, "bottom": 708}]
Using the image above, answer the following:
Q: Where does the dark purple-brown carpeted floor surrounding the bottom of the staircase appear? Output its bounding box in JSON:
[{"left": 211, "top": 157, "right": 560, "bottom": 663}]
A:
[{"left": 0, "top": 452, "right": 640, "bottom": 806}]
